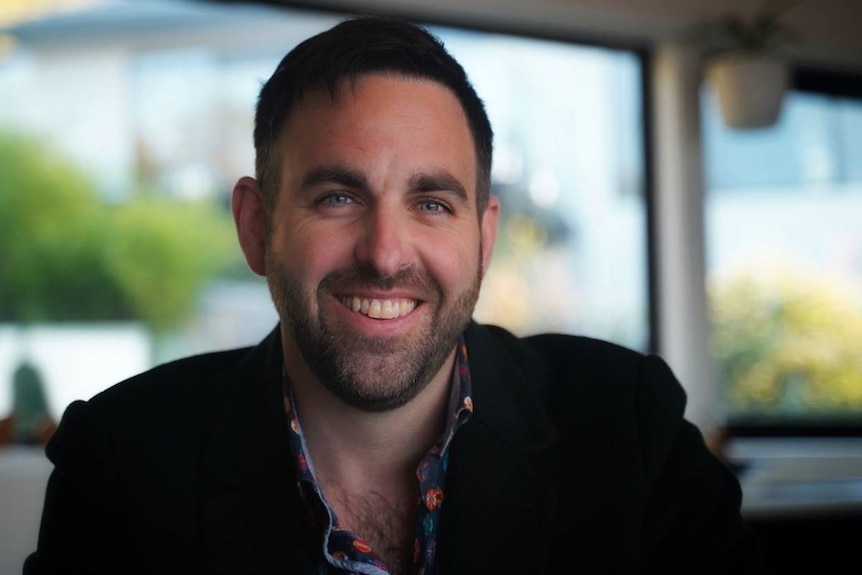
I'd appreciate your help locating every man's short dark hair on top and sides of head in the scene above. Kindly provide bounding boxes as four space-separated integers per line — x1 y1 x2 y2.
254 16 493 215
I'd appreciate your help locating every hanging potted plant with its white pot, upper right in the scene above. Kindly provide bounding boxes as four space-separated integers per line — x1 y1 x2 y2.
701 2 804 128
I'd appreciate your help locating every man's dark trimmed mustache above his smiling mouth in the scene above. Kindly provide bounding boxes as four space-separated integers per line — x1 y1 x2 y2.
318 264 443 297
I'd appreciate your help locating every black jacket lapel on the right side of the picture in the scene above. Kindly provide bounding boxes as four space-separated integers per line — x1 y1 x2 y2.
437 324 559 573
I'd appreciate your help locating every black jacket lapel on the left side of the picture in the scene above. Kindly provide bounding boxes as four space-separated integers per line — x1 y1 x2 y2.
200 328 312 574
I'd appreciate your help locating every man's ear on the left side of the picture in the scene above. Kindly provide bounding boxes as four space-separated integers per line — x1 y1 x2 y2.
231 176 267 276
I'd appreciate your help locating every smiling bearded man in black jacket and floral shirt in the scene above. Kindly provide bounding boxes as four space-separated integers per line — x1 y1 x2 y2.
25 14 762 575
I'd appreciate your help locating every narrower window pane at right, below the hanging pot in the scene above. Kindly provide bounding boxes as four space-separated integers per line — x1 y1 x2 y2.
703 88 862 425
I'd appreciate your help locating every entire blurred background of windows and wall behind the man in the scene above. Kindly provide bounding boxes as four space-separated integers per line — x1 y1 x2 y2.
0 0 862 573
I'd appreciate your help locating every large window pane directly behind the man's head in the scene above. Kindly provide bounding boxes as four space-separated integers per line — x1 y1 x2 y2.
0 0 648 424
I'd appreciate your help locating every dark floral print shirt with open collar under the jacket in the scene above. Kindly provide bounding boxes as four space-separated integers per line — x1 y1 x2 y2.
282 337 473 575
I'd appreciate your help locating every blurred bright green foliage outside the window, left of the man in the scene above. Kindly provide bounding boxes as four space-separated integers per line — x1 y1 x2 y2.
0 132 238 329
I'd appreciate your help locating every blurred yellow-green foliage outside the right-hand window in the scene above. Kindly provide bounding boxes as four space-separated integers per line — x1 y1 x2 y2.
710 261 862 417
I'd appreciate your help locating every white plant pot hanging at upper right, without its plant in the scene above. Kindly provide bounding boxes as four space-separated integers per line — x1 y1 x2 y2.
706 54 789 128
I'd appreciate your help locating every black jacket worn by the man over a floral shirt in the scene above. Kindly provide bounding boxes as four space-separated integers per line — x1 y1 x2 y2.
24 323 765 575
